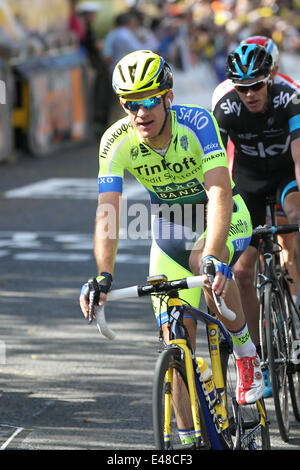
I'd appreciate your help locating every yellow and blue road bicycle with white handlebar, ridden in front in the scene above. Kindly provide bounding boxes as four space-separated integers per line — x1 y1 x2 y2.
90 275 270 450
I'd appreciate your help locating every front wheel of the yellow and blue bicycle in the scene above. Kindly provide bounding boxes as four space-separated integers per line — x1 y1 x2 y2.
152 348 209 450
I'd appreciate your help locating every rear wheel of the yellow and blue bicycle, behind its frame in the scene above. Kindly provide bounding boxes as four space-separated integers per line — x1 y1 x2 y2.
220 340 271 450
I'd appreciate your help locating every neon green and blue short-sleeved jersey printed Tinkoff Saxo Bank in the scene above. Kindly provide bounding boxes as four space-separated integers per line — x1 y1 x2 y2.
98 105 234 204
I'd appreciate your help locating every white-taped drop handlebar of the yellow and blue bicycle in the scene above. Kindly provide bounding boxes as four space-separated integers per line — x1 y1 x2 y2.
95 276 236 340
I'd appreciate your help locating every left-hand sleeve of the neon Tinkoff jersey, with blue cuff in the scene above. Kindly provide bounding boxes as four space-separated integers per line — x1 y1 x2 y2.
98 120 130 194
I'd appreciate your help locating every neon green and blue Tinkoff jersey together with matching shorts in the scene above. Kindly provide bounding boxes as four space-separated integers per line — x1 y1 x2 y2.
98 105 252 324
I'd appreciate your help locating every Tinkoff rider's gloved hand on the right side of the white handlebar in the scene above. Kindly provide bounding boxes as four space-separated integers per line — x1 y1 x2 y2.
200 256 232 298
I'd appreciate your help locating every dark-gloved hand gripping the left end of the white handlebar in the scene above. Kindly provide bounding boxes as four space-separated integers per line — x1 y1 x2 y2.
79 273 113 321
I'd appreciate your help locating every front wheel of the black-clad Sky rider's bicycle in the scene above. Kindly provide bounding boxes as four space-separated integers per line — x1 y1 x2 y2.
263 283 289 442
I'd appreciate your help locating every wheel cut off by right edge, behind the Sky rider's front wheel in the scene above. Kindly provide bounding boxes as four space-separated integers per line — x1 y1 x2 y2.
283 280 300 421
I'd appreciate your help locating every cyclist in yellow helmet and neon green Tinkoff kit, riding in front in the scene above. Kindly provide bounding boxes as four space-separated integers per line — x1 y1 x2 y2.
80 51 264 403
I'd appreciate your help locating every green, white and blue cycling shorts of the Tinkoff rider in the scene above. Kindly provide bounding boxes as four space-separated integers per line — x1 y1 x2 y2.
149 195 252 326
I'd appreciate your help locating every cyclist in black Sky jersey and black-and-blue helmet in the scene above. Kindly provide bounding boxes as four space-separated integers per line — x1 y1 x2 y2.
214 44 300 345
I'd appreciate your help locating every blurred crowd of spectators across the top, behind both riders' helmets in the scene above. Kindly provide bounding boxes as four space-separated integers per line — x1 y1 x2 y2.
0 0 300 154
